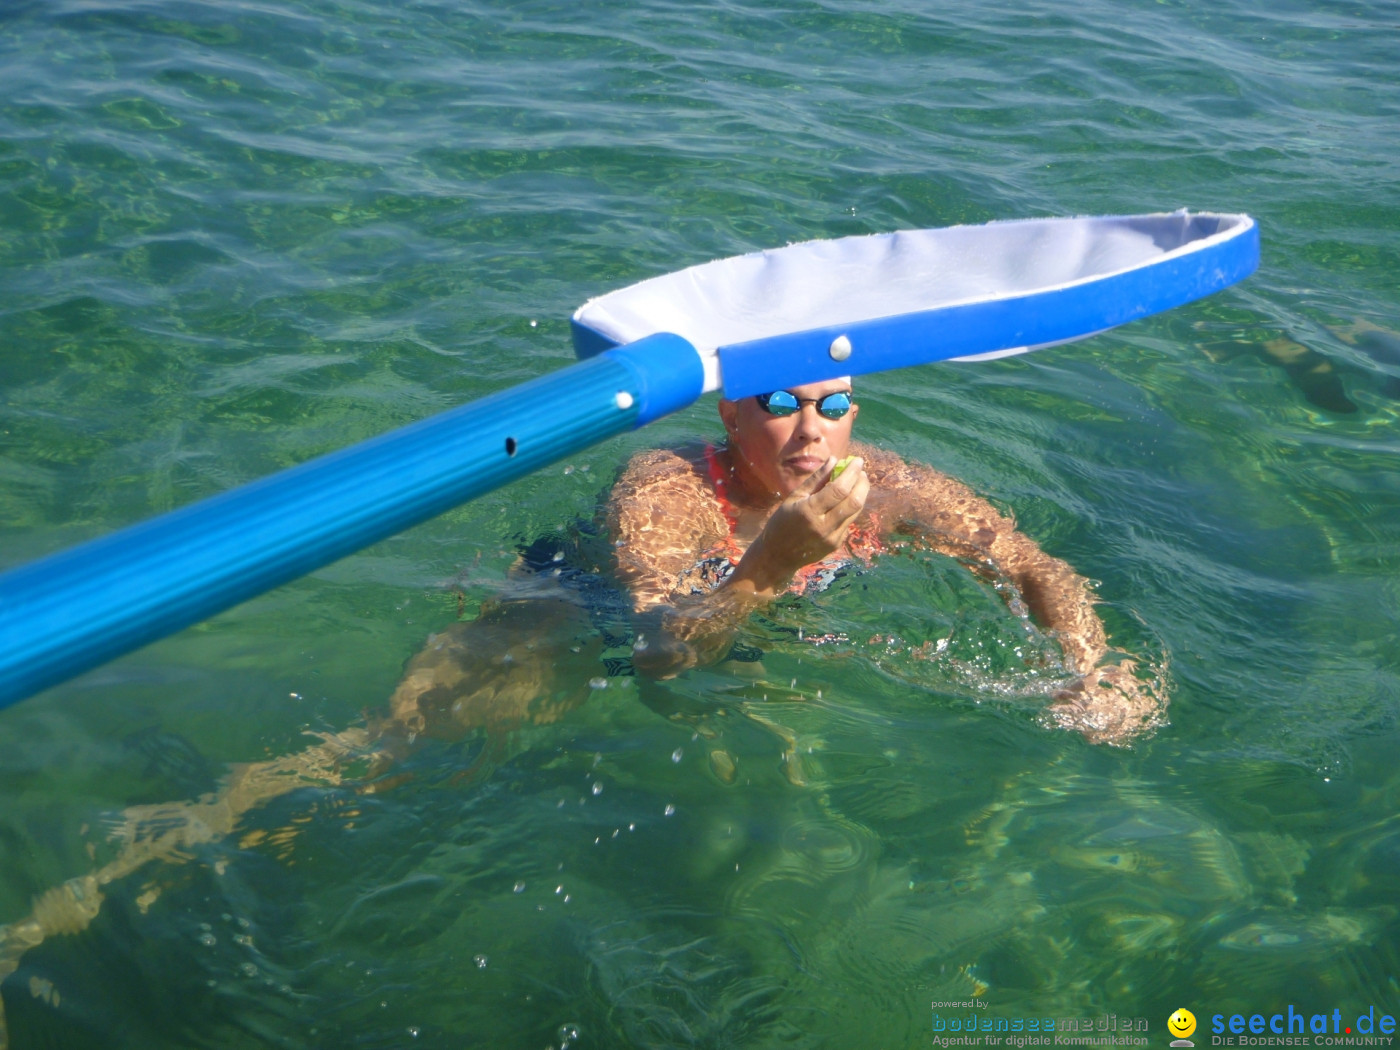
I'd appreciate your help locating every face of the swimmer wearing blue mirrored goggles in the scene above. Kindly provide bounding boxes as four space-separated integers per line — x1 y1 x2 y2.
720 378 860 497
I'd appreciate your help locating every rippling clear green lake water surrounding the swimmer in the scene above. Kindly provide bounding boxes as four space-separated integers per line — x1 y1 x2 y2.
0 0 1400 1050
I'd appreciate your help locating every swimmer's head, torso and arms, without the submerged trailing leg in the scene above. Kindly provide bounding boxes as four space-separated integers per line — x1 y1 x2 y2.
608 378 1162 743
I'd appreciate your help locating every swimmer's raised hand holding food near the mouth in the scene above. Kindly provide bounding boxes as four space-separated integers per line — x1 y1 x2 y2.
734 456 871 596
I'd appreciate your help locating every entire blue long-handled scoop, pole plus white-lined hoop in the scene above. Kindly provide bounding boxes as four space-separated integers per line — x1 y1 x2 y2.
0 211 1259 707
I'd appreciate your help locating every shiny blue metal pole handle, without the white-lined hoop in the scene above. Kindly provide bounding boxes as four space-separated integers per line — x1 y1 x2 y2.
0 335 704 707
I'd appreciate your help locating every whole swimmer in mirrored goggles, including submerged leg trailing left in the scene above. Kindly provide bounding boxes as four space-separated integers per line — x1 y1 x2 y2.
0 379 1165 1050
